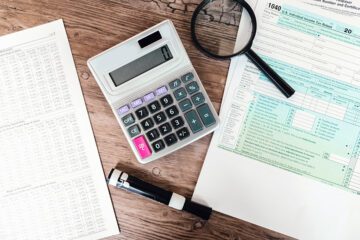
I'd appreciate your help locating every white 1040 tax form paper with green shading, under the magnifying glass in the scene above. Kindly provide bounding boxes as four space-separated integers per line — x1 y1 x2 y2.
193 0 360 240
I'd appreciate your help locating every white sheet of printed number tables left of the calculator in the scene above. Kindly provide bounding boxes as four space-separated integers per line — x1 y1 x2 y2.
0 20 119 240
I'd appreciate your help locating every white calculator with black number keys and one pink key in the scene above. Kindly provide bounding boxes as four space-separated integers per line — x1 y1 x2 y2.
88 20 219 163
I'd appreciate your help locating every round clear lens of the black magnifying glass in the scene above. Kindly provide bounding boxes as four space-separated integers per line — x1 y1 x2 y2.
194 0 253 57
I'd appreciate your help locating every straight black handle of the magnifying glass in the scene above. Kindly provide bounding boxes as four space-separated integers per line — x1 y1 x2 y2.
245 49 295 98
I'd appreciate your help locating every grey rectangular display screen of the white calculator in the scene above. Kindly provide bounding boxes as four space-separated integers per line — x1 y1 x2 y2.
110 45 173 87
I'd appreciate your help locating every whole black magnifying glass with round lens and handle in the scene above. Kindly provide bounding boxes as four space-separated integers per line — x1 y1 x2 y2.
191 0 295 98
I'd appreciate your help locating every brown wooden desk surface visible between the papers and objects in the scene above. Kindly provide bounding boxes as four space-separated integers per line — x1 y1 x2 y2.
0 0 289 240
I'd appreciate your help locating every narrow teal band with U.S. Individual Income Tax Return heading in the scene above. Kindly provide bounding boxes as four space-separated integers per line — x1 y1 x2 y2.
278 5 360 46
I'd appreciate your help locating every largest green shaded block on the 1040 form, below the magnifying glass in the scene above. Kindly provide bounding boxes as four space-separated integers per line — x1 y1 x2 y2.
220 94 360 194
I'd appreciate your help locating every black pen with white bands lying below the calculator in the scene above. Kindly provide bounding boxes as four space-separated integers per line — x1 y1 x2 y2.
107 168 212 220
